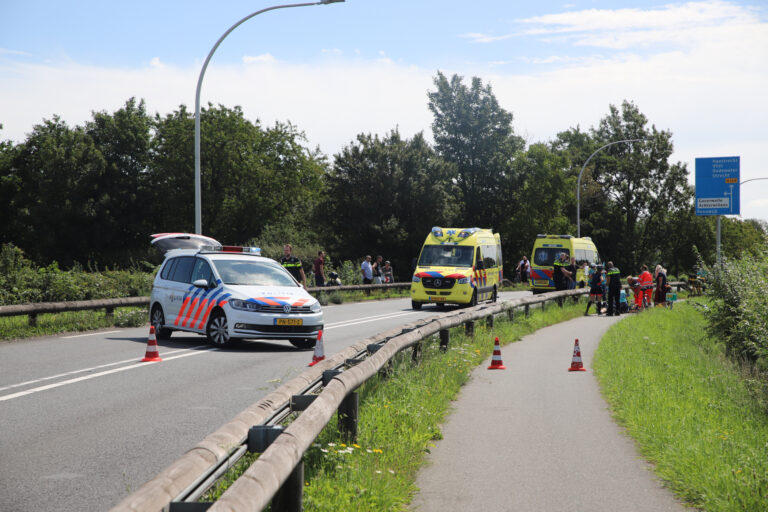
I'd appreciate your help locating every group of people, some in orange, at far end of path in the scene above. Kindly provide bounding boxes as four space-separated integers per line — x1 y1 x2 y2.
584 261 669 316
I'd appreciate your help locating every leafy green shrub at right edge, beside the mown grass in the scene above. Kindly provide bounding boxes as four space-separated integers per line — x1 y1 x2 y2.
707 243 768 370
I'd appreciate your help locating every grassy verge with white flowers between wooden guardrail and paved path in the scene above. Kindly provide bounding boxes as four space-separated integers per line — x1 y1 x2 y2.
203 301 584 511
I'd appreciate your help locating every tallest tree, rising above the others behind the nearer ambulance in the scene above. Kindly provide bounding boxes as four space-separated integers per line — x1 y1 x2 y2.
428 72 524 227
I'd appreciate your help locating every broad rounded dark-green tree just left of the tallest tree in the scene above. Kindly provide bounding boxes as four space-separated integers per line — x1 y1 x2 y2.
320 130 457 279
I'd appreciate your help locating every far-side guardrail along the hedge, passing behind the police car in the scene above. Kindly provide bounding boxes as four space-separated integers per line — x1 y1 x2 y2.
0 283 411 327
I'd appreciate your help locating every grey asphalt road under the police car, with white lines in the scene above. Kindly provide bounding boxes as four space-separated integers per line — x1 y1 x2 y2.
0 292 529 512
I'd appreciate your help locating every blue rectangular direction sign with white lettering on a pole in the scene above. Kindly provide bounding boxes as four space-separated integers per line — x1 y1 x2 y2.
696 156 741 215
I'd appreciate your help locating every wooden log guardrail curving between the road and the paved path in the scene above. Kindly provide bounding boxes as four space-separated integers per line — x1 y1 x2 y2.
112 288 588 512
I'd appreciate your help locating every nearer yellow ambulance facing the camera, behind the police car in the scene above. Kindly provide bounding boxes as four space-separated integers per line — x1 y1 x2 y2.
411 227 503 309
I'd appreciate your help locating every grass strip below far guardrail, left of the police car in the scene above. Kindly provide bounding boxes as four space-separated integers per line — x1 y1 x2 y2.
0 307 149 340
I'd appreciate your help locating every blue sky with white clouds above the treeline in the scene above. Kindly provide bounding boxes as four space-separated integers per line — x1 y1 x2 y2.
0 0 768 221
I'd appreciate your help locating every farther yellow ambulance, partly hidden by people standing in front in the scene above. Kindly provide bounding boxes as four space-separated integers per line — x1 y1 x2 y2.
529 235 600 293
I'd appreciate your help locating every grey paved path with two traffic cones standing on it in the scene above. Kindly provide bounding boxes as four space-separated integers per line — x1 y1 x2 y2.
412 316 688 512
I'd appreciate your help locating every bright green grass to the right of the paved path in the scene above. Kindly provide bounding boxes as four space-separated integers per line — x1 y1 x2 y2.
593 303 768 511
